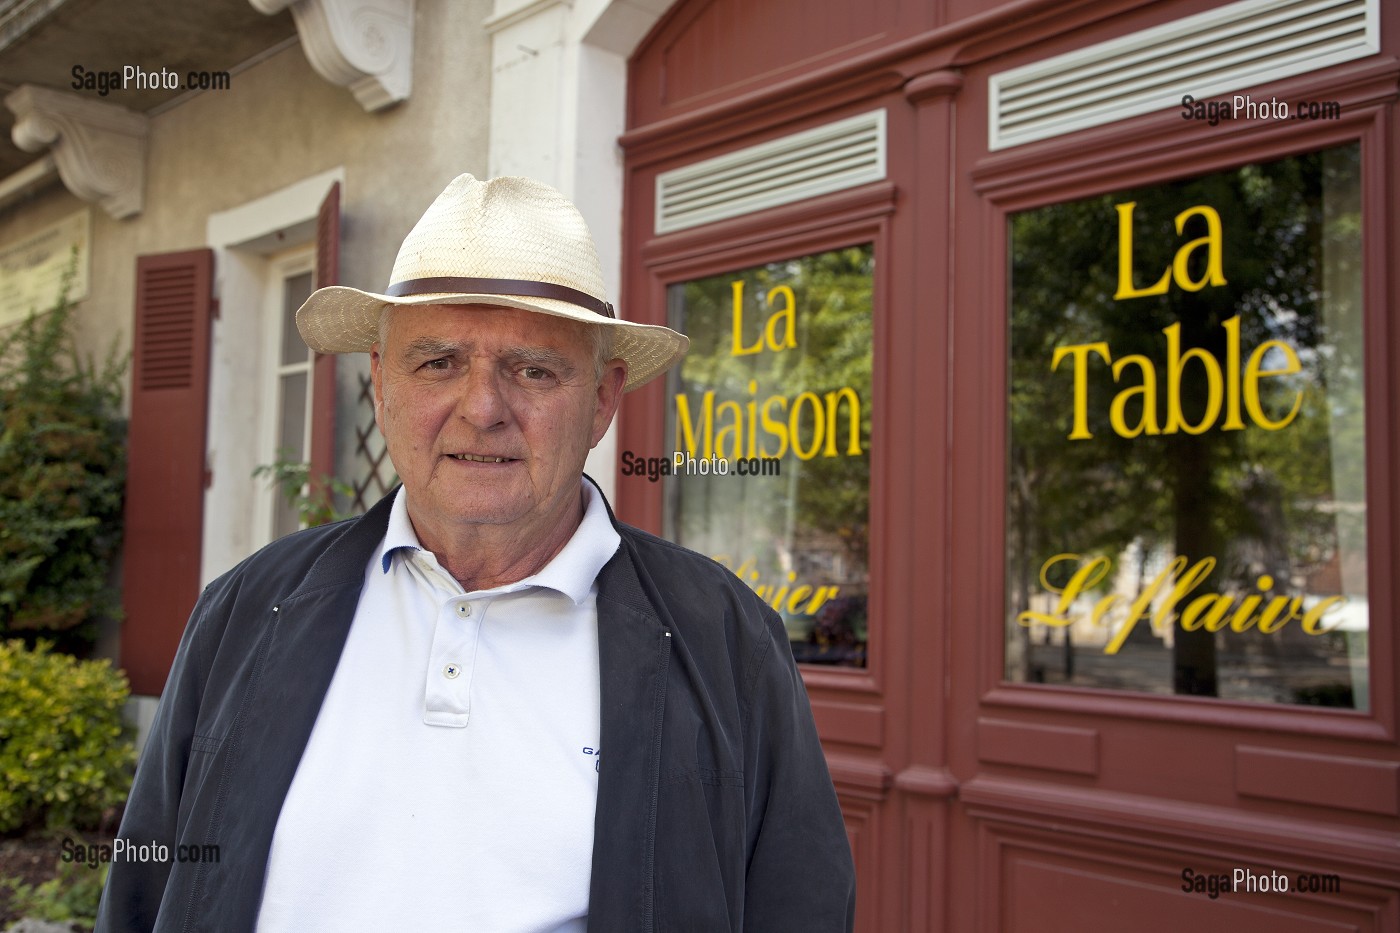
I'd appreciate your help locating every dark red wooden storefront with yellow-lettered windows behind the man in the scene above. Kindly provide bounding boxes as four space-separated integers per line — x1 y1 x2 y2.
617 0 1400 932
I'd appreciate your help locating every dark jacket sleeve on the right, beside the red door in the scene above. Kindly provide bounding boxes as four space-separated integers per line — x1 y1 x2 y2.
743 608 855 933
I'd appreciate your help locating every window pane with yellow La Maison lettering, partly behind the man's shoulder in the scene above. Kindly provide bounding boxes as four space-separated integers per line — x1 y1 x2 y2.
660 244 874 667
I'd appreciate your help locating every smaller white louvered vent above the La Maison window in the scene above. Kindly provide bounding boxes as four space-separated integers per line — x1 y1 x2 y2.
657 111 885 234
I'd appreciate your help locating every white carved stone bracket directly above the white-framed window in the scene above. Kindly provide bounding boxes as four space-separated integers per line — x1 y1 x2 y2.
248 0 414 112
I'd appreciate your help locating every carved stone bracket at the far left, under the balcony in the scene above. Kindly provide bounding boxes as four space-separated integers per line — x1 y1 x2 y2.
4 84 150 220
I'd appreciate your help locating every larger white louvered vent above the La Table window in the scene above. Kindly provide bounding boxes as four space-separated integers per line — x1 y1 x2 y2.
988 0 1380 150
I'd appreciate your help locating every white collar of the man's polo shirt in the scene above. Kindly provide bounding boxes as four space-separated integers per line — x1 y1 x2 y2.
377 479 622 605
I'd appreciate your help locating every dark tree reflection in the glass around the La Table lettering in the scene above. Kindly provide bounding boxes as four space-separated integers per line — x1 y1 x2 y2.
1007 146 1364 706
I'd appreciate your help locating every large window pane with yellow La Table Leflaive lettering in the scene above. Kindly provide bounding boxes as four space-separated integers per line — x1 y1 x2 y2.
1005 144 1369 709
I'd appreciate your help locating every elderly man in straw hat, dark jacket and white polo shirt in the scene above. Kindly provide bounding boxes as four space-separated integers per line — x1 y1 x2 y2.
98 175 854 933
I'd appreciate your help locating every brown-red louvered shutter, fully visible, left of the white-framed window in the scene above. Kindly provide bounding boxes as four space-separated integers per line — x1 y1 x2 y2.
122 249 216 695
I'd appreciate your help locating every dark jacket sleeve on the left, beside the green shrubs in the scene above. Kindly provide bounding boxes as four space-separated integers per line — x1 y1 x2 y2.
95 590 213 933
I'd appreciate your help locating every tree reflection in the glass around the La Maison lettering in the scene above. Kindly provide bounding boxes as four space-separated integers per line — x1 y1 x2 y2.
665 244 874 667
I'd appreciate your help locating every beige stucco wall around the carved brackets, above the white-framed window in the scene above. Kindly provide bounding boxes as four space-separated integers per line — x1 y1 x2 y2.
0 0 490 400
